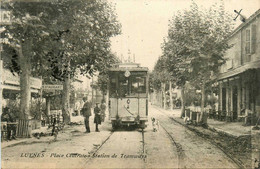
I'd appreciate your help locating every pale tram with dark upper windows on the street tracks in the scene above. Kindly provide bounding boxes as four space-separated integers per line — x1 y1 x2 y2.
108 63 148 129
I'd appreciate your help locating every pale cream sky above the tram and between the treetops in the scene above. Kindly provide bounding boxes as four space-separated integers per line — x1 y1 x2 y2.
109 0 260 70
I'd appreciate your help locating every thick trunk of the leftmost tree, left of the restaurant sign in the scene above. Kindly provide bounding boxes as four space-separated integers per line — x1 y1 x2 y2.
18 49 31 120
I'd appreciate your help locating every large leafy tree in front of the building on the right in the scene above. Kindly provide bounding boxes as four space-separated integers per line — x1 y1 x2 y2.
163 2 233 121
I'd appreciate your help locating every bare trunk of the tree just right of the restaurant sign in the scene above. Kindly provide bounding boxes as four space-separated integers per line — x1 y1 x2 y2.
62 75 70 124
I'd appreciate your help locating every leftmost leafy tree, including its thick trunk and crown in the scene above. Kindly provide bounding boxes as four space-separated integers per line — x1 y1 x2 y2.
1 2 58 119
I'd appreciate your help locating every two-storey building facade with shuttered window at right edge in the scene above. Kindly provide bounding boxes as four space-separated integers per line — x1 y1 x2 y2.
218 10 260 120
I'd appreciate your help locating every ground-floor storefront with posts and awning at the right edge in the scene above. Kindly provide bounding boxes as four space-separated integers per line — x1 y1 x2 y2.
218 61 260 120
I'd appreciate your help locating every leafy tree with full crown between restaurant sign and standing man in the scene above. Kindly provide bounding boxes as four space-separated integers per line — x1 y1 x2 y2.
44 0 120 121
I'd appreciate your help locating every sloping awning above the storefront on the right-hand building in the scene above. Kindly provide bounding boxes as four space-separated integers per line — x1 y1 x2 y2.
217 60 260 80
